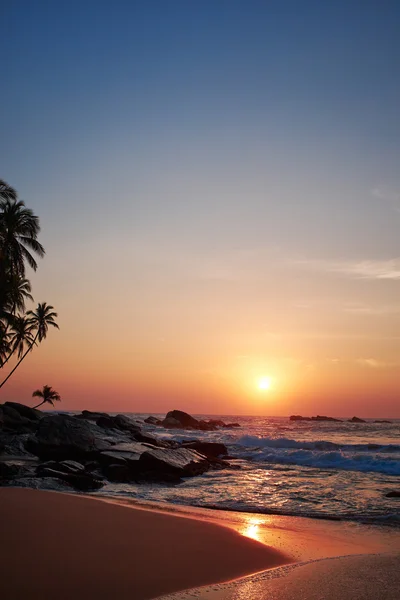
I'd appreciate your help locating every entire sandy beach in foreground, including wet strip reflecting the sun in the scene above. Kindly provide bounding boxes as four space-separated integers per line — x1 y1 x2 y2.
0 488 400 600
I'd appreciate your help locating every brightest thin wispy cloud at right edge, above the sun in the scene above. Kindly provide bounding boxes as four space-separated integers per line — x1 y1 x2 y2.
293 258 400 280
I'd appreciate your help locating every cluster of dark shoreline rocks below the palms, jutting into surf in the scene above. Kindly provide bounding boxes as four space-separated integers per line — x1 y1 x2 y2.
0 402 233 492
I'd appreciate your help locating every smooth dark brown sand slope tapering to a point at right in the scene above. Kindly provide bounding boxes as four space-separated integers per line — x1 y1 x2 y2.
0 488 290 600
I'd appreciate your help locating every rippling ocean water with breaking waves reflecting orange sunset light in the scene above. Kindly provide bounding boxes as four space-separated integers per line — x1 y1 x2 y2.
96 413 400 526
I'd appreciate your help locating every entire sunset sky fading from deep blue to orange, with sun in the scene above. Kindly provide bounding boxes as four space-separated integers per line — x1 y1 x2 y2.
0 0 400 418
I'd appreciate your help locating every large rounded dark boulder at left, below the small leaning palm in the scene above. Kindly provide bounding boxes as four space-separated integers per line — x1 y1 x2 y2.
27 415 112 460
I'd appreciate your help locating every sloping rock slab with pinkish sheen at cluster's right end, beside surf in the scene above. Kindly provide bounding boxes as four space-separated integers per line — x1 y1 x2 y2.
139 448 210 477
